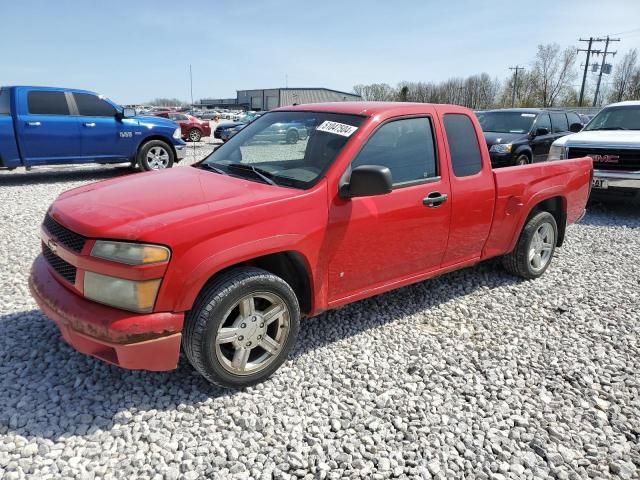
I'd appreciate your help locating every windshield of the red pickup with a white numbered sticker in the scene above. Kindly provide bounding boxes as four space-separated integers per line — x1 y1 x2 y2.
201 112 365 189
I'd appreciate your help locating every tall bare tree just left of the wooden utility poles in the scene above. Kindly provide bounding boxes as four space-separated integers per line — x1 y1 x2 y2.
532 43 577 107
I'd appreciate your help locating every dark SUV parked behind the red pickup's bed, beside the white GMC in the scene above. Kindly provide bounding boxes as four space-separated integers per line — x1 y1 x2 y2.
476 108 584 167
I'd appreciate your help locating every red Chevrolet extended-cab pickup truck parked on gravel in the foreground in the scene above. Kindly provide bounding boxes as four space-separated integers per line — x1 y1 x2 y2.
30 102 593 387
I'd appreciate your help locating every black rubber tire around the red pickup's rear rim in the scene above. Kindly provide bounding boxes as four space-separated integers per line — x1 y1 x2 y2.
502 212 558 279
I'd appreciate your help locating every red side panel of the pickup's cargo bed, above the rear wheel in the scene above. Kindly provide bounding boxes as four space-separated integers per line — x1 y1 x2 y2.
483 157 593 257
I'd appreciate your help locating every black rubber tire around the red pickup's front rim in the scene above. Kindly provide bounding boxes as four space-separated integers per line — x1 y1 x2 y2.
182 267 300 388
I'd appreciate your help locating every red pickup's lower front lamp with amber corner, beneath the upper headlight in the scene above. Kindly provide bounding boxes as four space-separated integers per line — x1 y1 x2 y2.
84 272 160 313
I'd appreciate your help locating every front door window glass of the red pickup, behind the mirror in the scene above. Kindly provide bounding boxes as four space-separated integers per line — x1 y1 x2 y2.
351 117 438 186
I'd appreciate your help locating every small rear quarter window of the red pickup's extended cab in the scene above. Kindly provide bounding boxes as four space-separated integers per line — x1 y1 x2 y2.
444 113 482 177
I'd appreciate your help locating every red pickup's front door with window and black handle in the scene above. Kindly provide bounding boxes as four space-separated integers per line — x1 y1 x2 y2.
329 116 451 304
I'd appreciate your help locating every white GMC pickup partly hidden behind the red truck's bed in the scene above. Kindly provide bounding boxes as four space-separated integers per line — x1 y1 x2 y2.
548 101 640 196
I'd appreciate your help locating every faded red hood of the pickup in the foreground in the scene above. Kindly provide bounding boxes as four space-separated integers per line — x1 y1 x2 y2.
49 167 301 240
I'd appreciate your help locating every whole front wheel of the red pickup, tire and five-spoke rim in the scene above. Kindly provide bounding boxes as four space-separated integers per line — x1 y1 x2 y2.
182 268 300 388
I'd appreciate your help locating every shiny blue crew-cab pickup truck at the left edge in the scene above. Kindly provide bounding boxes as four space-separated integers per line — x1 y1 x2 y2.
0 87 186 170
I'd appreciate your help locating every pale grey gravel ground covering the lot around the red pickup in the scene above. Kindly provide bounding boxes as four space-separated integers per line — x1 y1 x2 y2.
0 158 640 480
